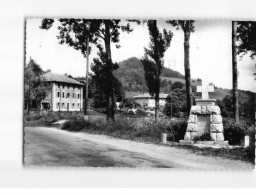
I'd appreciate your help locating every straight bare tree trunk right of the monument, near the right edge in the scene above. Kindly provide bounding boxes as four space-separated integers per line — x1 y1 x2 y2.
232 21 239 123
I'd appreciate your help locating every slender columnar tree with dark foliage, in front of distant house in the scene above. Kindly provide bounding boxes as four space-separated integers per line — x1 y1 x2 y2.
141 20 173 120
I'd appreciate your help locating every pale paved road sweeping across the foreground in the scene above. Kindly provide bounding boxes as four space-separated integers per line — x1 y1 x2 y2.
24 127 253 169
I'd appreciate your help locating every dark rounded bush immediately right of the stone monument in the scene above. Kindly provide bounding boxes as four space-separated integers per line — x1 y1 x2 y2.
223 118 247 145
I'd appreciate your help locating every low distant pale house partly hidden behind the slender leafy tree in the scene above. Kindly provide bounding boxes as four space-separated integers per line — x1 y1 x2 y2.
133 93 168 108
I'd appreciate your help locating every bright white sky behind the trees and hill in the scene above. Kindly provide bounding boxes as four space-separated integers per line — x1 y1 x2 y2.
26 18 256 92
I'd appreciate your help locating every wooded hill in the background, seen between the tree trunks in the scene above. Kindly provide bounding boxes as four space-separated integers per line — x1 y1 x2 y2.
114 57 254 102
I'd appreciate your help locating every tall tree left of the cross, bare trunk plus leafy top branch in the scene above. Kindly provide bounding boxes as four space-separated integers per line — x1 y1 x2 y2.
166 20 195 115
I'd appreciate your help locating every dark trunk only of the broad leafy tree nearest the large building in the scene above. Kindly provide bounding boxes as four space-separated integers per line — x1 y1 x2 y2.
105 20 115 121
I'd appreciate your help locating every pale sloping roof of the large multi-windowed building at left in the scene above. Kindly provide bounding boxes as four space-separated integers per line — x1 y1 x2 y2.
43 72 84 85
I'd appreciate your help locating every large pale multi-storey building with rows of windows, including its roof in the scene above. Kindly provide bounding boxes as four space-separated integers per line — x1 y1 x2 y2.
41 72 84 111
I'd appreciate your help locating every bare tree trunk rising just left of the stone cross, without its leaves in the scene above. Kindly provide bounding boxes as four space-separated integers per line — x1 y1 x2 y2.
183 21 192 116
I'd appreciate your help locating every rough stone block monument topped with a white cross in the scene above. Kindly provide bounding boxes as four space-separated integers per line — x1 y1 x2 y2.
180 81 228 145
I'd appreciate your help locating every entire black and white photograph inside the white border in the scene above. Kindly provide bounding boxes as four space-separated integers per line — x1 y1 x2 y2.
23 17 256 170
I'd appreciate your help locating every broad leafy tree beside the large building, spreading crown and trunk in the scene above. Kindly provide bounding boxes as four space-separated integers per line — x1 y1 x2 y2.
41 18 132 121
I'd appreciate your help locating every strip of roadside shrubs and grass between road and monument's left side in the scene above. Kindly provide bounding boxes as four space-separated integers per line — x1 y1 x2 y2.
61 117 187 143
